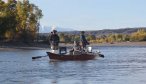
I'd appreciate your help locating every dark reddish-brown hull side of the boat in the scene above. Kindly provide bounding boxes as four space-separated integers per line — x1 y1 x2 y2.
47 52 97 60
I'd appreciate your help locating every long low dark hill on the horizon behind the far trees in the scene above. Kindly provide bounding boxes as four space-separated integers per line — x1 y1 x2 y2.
38 27 146 36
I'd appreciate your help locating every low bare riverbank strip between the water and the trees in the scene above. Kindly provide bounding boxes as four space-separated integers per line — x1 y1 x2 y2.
0 41 146 50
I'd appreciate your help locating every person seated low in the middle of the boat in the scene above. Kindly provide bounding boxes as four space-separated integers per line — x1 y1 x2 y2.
70 41 82 55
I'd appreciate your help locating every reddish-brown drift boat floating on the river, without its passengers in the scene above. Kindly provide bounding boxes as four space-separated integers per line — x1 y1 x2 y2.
46 47 104 60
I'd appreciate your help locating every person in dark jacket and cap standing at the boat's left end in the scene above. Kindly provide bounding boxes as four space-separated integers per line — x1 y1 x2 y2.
50 30 60 50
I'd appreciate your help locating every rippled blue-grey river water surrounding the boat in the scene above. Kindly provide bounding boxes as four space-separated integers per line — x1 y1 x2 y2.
0 46 146 84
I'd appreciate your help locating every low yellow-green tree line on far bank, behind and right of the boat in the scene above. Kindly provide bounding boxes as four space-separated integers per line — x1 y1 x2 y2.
56 29 146 43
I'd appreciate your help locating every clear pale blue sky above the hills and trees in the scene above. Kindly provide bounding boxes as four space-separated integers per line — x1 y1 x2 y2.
29 0 146 30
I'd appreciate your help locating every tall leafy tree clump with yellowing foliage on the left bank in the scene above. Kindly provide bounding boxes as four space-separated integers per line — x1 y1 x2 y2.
0 0 43 42
